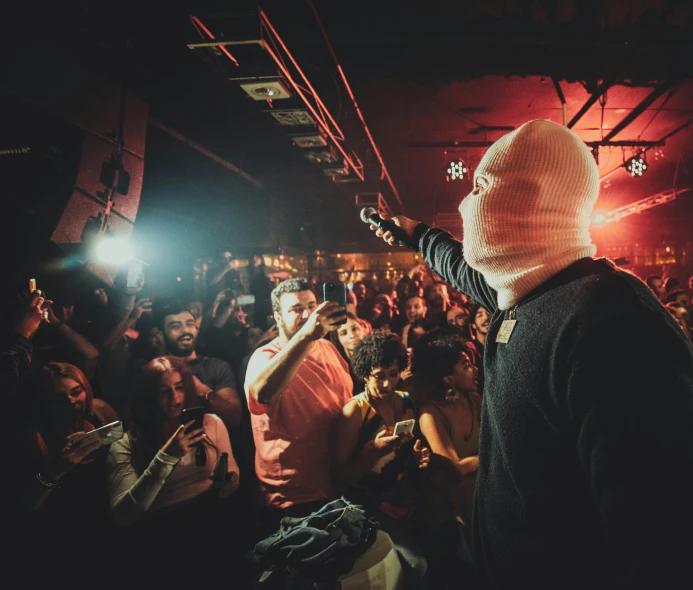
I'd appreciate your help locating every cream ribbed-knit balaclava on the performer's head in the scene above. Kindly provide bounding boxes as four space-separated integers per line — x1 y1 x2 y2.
460 121 599 309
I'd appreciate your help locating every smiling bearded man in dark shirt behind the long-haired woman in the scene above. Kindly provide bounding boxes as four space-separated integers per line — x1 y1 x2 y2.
153 299 242 430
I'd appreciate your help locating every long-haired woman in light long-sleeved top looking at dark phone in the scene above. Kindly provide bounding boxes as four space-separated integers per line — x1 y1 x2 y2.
108 357 239 532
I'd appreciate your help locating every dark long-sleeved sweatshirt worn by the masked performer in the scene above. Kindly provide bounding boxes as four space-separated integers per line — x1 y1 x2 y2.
414 224 693 590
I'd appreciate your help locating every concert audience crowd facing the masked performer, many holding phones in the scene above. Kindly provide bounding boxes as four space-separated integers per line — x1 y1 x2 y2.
2 246 693 588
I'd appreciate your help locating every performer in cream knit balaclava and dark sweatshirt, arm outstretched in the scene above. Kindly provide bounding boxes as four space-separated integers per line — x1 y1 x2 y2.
377 121 693 590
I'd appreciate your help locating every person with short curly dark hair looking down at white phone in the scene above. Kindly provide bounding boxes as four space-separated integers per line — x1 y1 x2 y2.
336 332 430 588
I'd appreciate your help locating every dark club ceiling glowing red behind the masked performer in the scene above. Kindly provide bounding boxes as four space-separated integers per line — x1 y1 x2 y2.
4 0 693 260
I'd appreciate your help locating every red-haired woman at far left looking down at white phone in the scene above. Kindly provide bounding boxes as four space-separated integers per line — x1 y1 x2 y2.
9 363 118 575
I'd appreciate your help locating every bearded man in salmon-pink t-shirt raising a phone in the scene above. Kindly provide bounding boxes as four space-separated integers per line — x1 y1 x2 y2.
245 279 353 516
